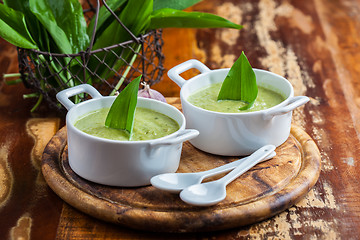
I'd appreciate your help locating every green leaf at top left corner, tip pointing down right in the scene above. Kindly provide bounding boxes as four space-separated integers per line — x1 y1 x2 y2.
0 4 37 49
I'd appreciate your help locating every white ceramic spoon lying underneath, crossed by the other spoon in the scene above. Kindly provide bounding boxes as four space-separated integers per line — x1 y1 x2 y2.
150 145 276 193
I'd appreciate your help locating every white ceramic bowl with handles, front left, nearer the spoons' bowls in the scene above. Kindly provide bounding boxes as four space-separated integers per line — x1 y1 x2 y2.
56 84 199 187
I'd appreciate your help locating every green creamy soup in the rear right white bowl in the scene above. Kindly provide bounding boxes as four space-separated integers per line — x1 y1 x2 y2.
187 82 285 113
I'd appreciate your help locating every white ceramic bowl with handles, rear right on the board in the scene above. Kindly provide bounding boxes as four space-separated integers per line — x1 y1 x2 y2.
168 59 309 156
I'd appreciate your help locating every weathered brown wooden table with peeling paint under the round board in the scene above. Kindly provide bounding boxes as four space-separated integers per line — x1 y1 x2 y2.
0 0 360 239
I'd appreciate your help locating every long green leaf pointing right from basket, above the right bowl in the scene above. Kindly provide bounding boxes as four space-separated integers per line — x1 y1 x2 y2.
149 8 242 29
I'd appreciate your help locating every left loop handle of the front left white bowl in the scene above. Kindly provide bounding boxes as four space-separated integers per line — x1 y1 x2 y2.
56 84 103 110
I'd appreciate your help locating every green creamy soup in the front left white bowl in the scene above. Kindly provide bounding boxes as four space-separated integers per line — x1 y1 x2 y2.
75 108 180 141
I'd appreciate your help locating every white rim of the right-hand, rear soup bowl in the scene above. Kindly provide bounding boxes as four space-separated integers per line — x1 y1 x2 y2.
180 68 294 116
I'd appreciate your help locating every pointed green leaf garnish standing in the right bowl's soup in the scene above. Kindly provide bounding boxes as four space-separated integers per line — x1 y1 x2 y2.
218 52 258 110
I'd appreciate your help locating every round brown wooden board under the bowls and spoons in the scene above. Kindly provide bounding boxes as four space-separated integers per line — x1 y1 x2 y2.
42 126 321 232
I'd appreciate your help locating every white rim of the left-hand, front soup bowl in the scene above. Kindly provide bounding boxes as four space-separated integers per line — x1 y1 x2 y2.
66 96 186 145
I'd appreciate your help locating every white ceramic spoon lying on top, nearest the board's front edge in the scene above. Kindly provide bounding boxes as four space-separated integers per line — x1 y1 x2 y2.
180 145 275 206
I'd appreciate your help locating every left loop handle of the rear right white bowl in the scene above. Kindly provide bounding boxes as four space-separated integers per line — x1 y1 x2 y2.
167 59 211 88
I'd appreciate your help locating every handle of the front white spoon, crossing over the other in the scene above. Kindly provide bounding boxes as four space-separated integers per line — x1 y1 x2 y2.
217 145 275 186
